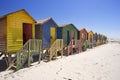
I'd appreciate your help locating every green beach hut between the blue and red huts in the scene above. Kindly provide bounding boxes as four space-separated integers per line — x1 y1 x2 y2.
57 24 78 47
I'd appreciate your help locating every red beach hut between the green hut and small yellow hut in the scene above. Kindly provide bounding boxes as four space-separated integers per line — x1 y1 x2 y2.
79 28 88 51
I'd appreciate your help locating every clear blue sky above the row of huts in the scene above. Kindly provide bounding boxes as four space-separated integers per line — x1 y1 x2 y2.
0 0 120 39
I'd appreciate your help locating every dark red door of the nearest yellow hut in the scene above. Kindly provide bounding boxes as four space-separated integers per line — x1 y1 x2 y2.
23 23 32 44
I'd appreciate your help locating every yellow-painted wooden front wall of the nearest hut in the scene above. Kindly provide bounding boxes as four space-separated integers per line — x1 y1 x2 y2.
0 9 35 53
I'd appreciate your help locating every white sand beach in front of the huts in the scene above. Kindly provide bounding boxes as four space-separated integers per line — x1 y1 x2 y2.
0 43 120 80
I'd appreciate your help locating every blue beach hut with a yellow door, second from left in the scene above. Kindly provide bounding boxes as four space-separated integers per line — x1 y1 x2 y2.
35 18 58 49
